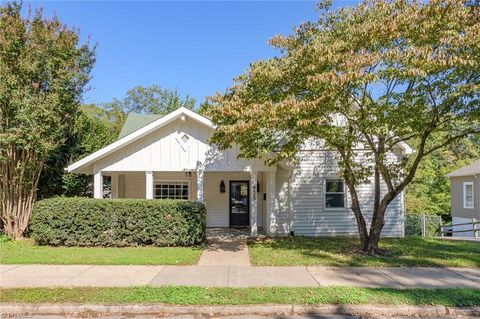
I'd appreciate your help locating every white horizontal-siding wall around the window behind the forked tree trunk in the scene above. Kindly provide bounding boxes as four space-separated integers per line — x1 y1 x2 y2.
291 150 404 237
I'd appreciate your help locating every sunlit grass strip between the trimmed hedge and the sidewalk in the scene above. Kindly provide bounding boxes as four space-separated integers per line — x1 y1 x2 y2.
0 241 203 265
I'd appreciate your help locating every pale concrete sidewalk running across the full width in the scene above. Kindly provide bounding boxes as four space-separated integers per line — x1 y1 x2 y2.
0 265 480 289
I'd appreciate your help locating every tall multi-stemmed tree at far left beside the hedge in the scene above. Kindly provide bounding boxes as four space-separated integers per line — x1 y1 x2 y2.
0 2 95 239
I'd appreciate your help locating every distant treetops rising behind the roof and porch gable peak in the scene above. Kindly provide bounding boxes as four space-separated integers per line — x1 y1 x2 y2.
104 84 195 133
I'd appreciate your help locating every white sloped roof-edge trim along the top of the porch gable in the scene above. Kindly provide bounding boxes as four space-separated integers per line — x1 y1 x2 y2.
66 107 215 173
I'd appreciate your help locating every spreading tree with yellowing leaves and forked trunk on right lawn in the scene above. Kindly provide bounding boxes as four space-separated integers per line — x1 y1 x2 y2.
208 0 480 254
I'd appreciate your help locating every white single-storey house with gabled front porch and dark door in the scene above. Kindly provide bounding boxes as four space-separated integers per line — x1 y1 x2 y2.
67 108 412 237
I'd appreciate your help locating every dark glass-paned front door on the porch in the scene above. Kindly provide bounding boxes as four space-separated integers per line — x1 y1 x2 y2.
230 181 250 227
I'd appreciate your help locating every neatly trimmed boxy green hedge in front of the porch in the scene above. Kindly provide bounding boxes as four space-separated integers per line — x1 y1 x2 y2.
30 197 206 247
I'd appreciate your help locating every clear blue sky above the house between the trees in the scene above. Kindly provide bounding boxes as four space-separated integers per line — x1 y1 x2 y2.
24 1 358 104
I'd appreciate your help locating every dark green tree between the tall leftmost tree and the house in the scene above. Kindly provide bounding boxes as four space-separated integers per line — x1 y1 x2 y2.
37 104 117 198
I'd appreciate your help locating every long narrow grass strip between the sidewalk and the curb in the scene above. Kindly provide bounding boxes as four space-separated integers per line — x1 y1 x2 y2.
0 286 480 306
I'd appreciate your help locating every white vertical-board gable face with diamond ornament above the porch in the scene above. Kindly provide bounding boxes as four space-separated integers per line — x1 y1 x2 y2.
94 118 272 172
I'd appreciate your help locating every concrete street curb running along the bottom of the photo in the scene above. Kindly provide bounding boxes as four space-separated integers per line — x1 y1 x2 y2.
0 303 480 317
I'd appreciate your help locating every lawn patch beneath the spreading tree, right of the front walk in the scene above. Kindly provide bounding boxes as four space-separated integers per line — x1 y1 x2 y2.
249 237 480 267
